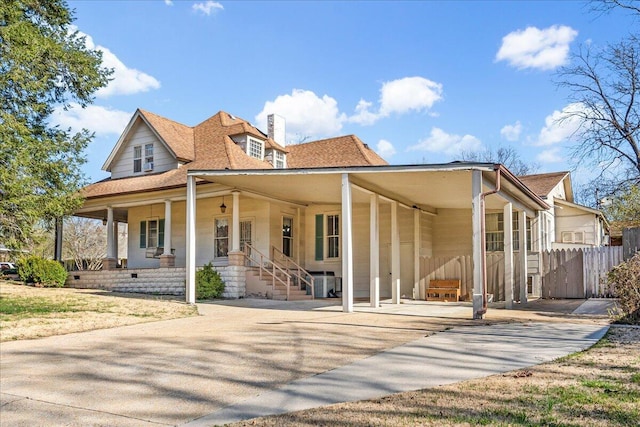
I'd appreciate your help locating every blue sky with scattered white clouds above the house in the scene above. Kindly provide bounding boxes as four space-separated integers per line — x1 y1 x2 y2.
53 0 635 189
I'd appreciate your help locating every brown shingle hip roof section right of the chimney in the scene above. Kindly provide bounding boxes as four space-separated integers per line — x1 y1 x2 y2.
287 135 388 168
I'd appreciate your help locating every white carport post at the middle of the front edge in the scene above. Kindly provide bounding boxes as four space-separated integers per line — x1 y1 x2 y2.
342 173 353 313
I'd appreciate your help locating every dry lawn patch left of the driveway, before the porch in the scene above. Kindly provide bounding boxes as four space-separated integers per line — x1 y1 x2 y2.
0 282 198 341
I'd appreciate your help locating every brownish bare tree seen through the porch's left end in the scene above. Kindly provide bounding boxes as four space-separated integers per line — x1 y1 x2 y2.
62 217 107 270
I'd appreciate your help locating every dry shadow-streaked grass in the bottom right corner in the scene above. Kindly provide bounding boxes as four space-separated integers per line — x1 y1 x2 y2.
232 327 640 427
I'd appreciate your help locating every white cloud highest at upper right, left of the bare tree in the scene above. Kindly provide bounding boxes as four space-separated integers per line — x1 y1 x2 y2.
496 25 578 70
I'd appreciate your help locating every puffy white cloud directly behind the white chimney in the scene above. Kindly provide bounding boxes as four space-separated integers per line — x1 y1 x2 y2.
255 89 346 139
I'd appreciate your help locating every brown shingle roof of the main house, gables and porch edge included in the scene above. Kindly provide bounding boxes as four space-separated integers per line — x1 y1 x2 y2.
83 109 387 198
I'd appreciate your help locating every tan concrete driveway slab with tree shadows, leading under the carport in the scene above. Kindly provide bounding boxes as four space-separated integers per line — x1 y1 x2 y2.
0 300 606 426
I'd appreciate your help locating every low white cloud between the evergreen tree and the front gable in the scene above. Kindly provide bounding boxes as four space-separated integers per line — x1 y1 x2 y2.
51 103 131 136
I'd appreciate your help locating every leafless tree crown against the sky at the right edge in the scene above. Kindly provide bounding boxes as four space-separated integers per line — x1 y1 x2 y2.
558 36 640 194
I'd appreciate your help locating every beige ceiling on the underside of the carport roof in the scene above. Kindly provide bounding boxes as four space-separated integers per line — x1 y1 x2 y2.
190 168 520 210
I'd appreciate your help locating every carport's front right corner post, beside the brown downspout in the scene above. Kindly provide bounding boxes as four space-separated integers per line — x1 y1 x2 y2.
471 170 485 319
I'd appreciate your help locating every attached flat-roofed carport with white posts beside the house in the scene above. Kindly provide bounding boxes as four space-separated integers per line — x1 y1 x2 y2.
186 162 548 319
